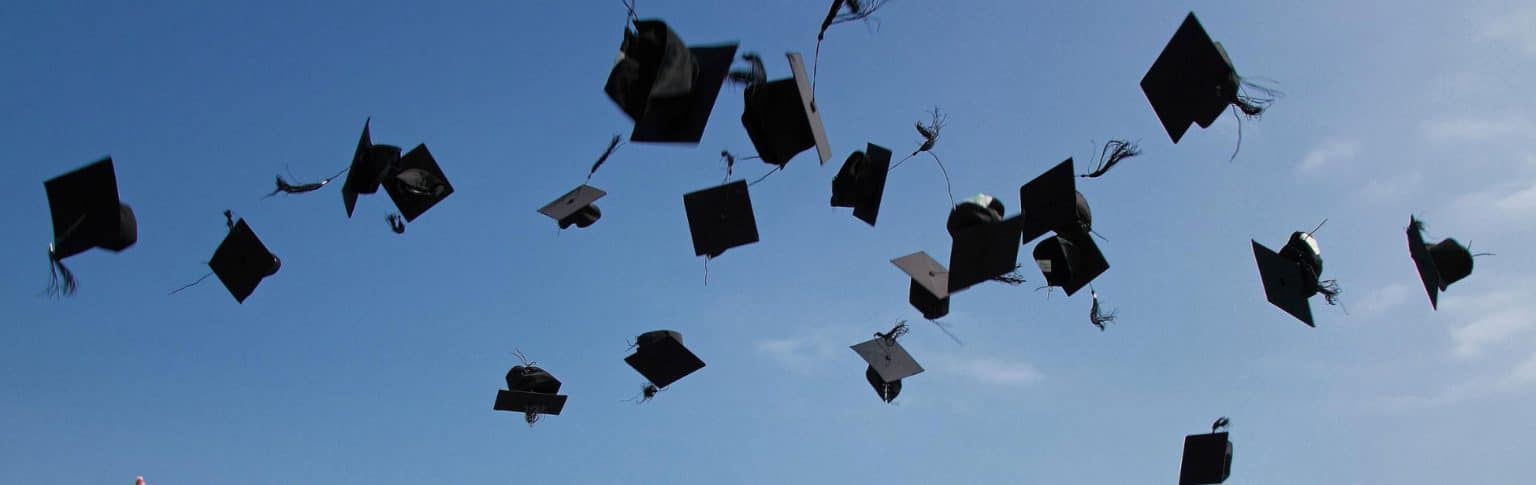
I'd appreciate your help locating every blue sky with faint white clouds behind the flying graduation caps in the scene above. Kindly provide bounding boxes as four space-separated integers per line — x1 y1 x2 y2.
0 0 1536 485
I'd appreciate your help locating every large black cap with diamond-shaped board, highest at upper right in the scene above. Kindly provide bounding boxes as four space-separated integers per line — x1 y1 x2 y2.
1141 12 1241 143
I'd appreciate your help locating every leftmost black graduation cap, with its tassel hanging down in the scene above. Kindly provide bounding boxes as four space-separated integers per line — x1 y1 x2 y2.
43 157 138 295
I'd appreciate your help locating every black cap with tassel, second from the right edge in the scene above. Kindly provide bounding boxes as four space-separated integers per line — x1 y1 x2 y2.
1250 232 1339 327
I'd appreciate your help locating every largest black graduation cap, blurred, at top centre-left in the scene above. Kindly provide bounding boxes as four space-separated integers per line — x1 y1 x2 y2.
604 20 736 143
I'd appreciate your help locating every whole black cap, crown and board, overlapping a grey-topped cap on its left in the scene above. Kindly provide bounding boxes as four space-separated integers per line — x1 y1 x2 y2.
946 193 1023 293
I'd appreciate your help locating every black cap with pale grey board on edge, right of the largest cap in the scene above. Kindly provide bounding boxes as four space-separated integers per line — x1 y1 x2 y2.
742 52 833 166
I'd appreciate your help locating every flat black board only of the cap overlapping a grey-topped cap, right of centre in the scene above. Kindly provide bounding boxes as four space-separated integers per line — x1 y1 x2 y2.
948 216 1023 293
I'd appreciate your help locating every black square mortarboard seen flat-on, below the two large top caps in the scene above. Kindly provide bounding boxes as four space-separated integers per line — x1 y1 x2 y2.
682 180 757 258
